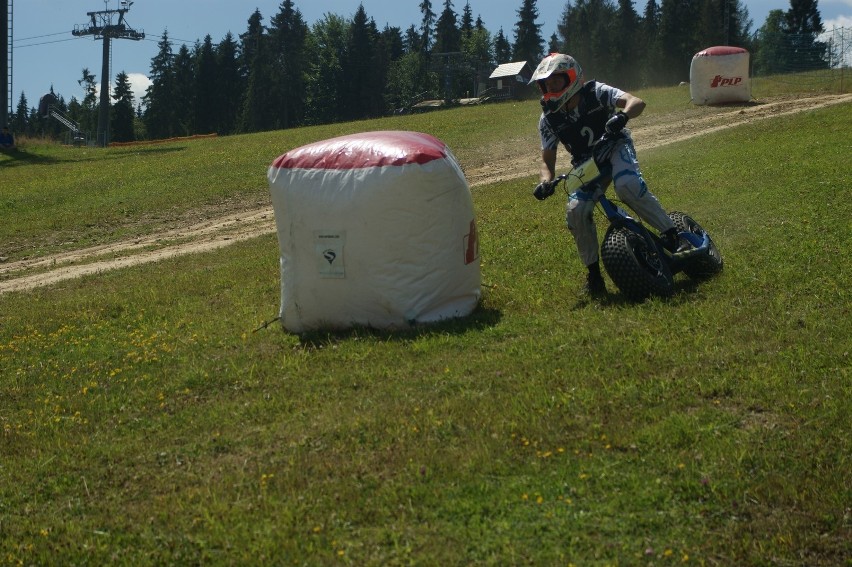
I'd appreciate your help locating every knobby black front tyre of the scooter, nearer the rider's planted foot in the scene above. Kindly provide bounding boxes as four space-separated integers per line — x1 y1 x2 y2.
601 226 674 301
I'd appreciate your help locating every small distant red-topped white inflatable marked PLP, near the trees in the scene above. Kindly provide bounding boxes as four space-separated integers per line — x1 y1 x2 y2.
689 46 751 105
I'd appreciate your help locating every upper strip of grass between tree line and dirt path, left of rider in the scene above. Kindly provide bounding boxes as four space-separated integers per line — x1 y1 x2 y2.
0 101 539 259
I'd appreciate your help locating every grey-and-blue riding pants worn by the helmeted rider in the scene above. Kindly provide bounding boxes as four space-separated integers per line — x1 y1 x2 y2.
565 137 674 266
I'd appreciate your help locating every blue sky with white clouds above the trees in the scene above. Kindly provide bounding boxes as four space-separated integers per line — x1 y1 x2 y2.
10 0 852 111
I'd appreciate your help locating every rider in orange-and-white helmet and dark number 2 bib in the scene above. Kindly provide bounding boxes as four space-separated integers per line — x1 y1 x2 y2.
530 53 689 296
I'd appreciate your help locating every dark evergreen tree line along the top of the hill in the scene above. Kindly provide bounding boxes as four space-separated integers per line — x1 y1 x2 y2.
12 0 826 141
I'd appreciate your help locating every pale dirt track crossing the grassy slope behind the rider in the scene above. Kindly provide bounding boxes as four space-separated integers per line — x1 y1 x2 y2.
0 94 852 293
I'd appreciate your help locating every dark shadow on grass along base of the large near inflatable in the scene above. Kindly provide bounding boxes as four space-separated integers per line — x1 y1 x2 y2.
284 305 503 350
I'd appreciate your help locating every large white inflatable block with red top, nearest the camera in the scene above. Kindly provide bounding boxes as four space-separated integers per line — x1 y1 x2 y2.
268 131 481 333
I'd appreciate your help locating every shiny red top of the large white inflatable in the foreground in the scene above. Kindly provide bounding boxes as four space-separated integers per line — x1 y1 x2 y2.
272 130 447 169
